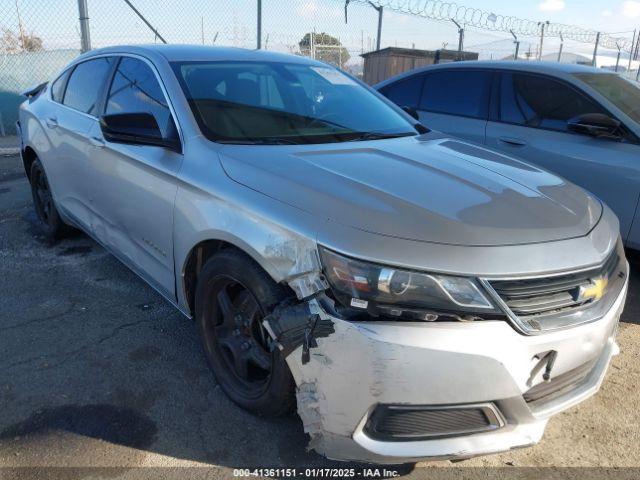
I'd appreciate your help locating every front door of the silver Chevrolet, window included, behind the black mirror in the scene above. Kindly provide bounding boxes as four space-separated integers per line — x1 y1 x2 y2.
90 57 183 299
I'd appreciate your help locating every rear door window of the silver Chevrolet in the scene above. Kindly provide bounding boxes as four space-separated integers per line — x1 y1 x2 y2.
63 57 113 115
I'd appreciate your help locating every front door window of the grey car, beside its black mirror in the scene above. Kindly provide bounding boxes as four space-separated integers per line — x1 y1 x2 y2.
500 73 606 131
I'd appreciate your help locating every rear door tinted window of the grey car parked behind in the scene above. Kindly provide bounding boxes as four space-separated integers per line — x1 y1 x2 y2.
420 70 491 118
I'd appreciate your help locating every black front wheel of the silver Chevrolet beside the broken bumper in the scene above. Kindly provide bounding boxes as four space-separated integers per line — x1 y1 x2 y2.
195 249 295 417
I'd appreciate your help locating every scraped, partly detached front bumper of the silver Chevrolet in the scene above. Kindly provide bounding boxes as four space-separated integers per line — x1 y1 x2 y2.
270 278 627 463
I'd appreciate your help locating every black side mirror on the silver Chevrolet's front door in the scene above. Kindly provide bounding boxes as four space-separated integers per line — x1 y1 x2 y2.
100 113 181 152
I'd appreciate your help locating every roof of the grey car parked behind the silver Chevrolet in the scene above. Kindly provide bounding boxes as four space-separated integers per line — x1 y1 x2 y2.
374 60 612 88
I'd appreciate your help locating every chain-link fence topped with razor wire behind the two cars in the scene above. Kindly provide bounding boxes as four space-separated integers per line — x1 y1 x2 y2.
0 0 638 137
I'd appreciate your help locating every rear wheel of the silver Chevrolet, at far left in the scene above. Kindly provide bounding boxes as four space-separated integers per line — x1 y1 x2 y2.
29 159 73 240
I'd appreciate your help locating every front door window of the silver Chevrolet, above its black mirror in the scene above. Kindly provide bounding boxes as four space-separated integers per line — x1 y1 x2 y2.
105 57 173 137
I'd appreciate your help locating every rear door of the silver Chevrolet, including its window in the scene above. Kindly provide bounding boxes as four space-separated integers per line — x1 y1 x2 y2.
44 57 113 228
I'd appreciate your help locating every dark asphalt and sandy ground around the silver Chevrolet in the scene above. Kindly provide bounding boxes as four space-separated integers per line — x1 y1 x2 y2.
0 152 640 478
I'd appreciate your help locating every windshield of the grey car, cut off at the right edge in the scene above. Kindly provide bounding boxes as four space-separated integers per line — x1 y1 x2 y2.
574 73 640 122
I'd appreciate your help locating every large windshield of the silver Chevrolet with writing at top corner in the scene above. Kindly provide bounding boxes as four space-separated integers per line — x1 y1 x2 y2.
172 62 417 144
